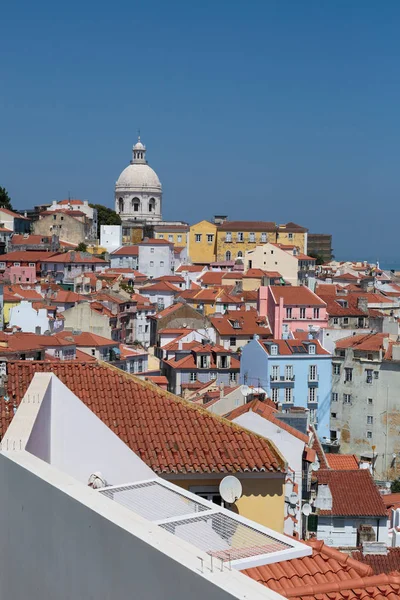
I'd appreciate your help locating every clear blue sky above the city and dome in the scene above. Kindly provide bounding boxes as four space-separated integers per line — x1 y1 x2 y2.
0 0 400 261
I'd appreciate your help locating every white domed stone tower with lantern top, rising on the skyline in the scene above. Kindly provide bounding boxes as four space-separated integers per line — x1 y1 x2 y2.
115 136 162 223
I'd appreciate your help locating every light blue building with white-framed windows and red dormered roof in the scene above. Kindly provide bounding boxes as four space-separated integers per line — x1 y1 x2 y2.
240 336 332 441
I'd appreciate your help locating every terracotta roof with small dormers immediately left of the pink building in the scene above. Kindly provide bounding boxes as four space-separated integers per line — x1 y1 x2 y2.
210 309 271 337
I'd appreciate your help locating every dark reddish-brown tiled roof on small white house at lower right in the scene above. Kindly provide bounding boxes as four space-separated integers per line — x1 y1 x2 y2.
316 469 386 517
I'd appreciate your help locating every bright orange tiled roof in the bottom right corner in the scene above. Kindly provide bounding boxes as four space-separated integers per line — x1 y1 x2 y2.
242 540 400 600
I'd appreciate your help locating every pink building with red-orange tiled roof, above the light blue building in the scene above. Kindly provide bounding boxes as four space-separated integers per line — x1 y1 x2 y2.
258 285 328 339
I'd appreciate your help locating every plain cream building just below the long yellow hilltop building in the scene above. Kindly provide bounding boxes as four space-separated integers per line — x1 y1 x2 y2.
244 243 298 285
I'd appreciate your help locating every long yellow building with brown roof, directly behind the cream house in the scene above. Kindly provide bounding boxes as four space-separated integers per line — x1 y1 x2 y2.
217 221 308 261
